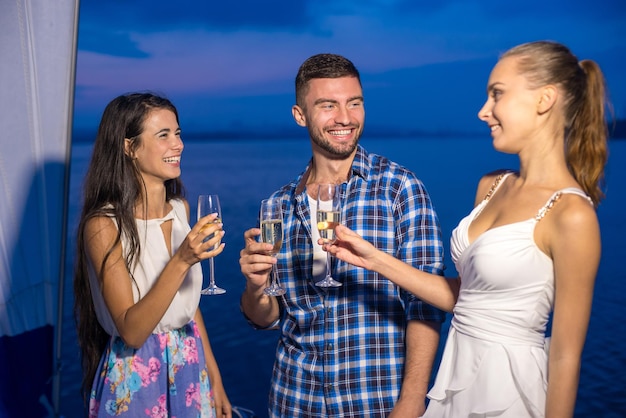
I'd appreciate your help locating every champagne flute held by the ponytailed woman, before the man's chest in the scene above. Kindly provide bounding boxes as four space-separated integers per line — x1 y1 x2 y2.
315 184 341 287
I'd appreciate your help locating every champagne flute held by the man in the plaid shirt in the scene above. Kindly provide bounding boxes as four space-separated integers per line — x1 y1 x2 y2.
261 199 285 296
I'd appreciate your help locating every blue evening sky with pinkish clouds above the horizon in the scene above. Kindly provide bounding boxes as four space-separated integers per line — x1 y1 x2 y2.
74 0 626 136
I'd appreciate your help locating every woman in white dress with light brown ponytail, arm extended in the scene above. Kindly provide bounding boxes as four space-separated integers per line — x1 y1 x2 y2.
326 41 607 418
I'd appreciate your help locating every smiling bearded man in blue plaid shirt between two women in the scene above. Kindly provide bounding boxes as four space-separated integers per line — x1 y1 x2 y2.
240 54 445 417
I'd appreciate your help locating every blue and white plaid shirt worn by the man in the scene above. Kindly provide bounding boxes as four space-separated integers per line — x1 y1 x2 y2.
254 145 445 417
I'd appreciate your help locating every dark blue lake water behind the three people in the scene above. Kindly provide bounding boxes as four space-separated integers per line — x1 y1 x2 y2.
60 136 626 418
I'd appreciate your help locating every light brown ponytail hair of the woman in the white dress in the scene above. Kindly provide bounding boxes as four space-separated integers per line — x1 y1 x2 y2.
502 41 609 206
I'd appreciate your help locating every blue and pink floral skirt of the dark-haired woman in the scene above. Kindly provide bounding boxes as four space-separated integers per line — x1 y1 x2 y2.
89 321 215 418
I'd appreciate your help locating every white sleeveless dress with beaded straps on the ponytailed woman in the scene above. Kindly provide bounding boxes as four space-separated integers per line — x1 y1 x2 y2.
423 171 589 418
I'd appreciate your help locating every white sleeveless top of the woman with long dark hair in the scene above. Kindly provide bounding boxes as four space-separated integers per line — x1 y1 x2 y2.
89 199 202 336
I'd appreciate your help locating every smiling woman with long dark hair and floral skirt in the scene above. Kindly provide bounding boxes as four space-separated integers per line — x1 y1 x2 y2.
74 93 231 417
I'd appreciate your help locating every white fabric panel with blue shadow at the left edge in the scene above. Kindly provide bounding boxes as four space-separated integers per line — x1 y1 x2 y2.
0 0 78 336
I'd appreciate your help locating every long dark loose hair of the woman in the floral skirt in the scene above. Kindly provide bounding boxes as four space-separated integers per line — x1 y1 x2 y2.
74 93 185 401
